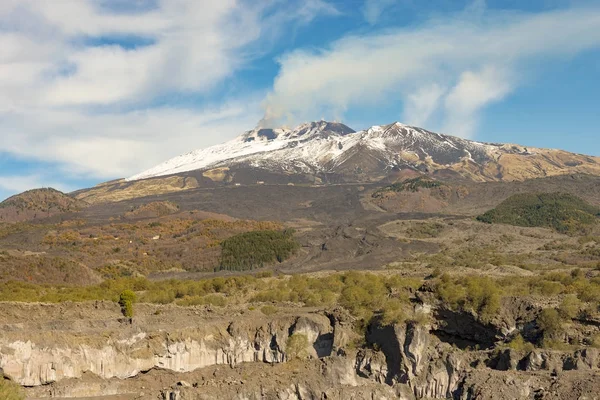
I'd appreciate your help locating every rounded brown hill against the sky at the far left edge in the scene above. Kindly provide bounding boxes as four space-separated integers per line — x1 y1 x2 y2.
0 188 88 223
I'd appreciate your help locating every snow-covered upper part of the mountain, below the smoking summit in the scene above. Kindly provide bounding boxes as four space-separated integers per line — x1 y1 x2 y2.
127 121 498 181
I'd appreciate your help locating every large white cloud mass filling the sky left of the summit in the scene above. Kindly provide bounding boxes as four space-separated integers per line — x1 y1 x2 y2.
0 0 337 190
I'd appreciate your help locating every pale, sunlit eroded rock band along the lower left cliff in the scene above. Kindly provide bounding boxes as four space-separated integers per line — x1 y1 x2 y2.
0 315 333 386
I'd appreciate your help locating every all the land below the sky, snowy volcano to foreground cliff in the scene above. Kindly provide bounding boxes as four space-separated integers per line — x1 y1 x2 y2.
0 121 600 400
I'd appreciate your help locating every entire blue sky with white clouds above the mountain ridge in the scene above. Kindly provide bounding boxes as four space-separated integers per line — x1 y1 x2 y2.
0 0 600 198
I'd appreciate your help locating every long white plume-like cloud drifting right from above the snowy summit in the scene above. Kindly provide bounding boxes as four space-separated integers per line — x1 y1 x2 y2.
264 7 600 136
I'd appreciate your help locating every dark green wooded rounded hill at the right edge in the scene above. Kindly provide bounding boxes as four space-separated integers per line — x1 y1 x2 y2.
477 193 600 233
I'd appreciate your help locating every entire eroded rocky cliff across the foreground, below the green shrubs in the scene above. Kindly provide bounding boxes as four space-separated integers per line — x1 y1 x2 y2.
0 303 600 400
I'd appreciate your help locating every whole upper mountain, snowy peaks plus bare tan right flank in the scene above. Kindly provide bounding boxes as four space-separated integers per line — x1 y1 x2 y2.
127 121 600 183
